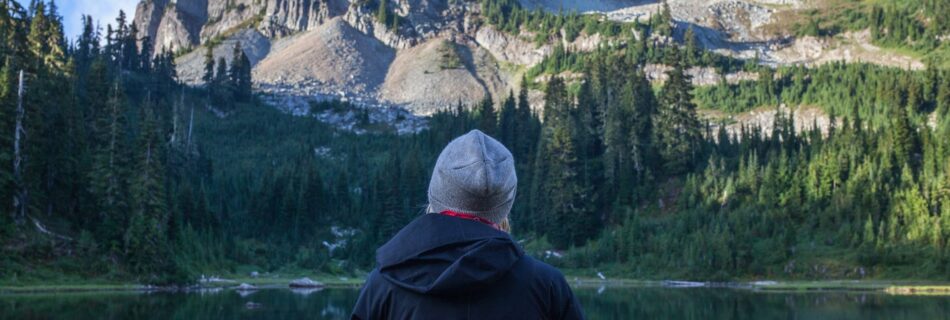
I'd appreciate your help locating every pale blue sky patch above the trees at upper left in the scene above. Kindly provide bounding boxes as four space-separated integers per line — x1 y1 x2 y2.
17 0 139 39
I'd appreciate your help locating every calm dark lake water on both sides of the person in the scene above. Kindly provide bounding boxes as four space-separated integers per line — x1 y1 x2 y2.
0 288 950 320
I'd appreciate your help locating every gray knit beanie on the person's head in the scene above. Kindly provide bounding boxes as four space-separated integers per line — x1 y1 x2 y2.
429 130 518 223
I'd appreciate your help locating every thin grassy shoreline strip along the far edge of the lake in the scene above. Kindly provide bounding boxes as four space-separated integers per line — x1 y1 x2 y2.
7 276 950 295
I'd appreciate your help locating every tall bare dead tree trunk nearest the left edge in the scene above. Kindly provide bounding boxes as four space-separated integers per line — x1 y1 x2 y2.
13 70 29 225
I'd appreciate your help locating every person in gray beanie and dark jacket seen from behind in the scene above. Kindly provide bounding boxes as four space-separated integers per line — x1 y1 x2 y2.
351 130 584 320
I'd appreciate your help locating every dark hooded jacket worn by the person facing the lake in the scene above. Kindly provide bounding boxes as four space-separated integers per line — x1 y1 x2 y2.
352 214 584 320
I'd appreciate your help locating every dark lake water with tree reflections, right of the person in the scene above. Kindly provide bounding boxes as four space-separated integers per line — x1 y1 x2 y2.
577 288 950 319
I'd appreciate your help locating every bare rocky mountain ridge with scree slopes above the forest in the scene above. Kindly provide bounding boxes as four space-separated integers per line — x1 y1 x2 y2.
135 0 920 124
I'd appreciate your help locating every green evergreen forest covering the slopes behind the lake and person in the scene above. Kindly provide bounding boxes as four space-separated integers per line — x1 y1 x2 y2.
0 0 950 284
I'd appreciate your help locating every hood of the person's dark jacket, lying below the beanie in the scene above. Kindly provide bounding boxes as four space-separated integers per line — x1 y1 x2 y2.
376 214 524 295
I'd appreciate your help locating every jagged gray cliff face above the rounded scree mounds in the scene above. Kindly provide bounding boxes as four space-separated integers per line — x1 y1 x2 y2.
135 0 477 51
